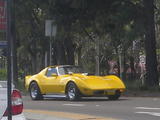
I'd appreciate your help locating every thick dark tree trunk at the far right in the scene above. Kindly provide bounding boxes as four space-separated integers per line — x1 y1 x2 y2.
143 0 159 87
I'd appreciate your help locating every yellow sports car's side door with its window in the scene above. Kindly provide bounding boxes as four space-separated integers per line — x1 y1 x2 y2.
43 67 61 93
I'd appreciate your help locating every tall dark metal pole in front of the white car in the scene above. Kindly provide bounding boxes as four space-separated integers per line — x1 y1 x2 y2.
6 0 12 120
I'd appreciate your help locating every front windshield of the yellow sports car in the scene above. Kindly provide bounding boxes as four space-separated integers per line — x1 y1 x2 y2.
58 66 85 75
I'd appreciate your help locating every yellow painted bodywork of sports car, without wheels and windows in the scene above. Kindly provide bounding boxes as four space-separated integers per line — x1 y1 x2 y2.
25 66 126 96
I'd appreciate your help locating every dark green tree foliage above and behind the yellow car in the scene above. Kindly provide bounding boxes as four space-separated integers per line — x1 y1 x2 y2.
15 0 160 87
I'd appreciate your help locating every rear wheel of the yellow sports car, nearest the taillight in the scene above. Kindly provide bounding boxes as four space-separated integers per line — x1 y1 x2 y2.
29 82 43 100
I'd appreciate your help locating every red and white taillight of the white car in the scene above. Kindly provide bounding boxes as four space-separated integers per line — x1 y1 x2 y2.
4 90 23 116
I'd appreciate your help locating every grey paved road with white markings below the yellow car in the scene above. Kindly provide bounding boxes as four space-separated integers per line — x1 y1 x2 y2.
24 96 160 120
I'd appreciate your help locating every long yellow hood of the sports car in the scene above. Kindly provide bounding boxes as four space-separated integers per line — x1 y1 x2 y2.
73 74 123 89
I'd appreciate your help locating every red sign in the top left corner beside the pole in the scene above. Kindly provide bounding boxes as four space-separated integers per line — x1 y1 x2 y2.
0 0 7 30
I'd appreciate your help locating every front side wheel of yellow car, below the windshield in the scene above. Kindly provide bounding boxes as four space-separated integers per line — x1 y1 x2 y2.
66 82 80 101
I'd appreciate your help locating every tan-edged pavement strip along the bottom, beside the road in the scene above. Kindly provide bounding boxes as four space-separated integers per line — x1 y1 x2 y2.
24 109 117 120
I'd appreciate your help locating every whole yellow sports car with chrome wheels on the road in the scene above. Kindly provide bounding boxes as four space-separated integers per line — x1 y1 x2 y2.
25 65 125 101
